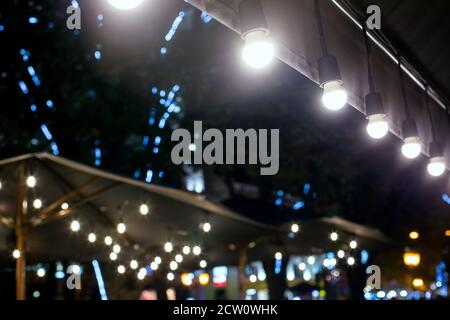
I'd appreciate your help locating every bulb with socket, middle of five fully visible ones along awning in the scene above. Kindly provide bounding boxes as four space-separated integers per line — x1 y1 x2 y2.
365 92 389 140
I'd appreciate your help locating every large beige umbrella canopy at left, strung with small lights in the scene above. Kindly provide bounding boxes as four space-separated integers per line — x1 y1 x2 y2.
0 153 281 265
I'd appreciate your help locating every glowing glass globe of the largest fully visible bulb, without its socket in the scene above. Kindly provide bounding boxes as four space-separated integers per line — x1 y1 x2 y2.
242 29 275 69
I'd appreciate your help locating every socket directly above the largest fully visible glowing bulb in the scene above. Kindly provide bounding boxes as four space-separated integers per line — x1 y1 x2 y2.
239 0 269 39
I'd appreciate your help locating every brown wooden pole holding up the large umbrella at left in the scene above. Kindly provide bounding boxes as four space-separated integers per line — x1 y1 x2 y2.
15 162 26 300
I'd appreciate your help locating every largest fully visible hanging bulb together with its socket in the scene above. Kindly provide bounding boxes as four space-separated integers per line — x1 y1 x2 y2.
239 0 275 69
